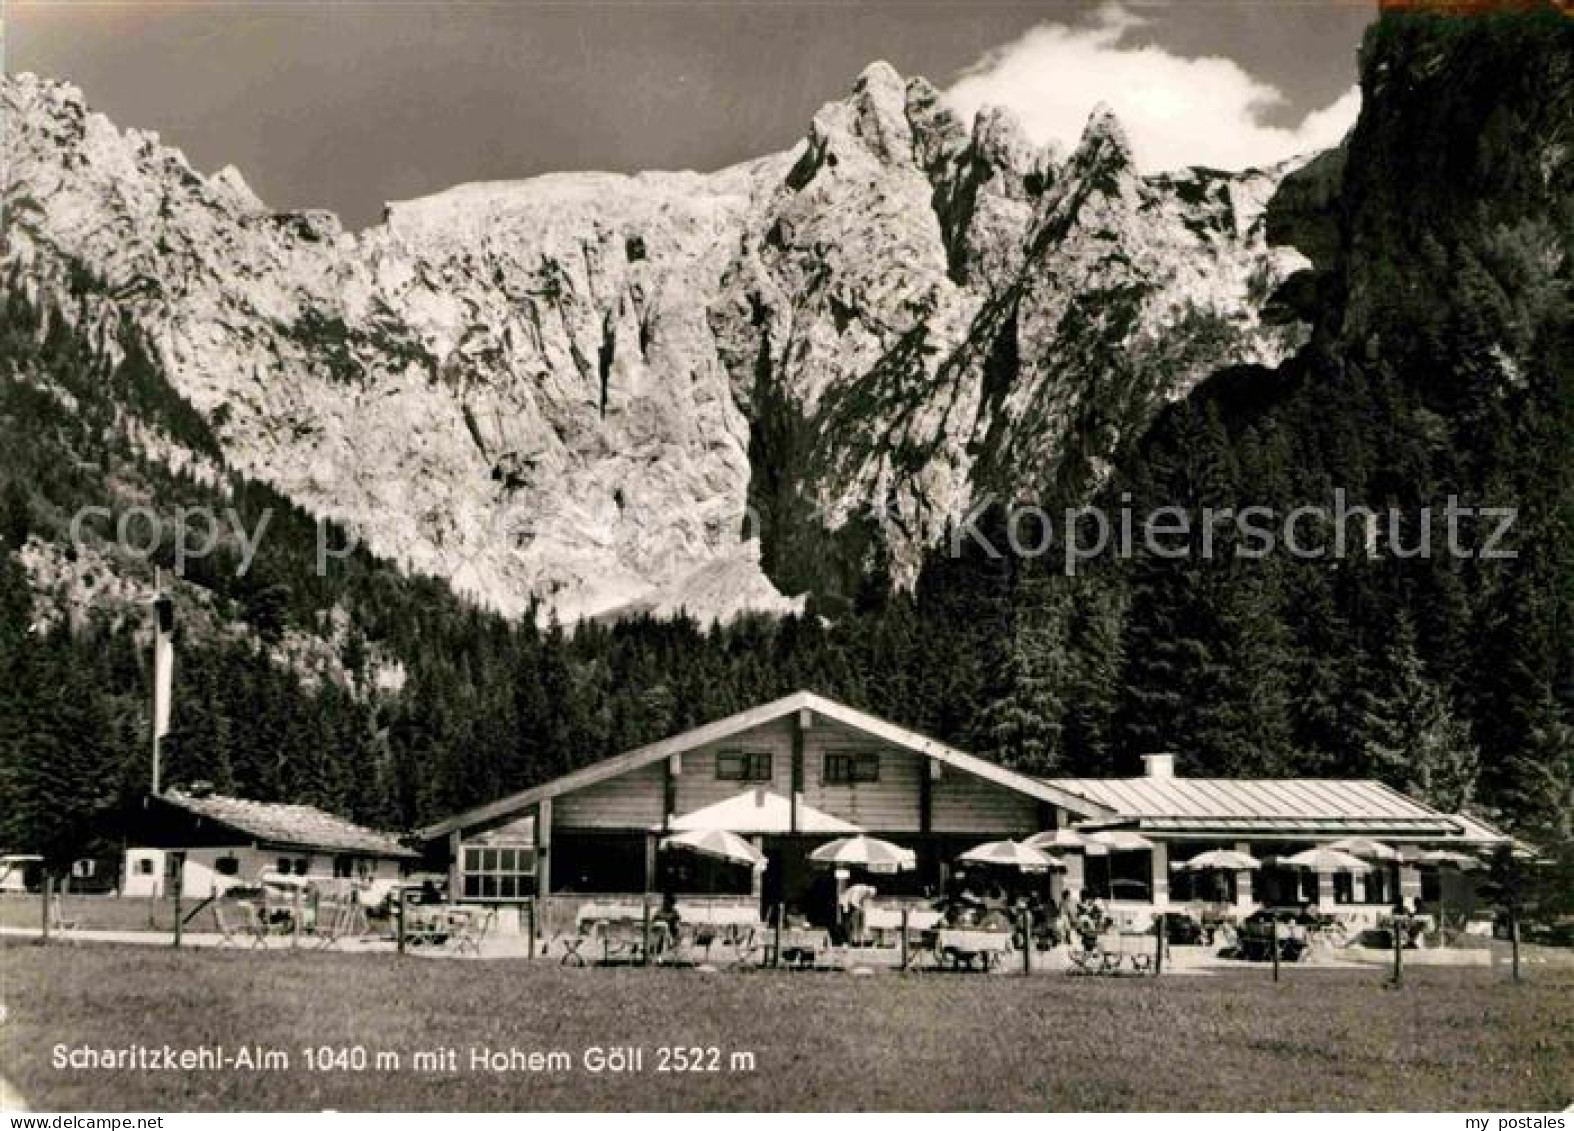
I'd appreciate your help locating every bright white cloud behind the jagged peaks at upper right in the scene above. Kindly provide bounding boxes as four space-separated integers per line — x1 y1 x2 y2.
946 5 1362 171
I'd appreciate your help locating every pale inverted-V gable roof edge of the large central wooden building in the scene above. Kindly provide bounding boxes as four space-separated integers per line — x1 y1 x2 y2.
420 691 1110 840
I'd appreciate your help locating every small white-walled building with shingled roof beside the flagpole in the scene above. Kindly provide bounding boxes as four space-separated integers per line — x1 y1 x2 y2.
121 790 419 898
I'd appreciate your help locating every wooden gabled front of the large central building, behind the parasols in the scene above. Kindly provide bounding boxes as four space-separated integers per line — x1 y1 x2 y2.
425 692 1110 898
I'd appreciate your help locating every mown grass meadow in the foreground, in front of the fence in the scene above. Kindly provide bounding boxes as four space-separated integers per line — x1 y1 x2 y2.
0 942 1574 1111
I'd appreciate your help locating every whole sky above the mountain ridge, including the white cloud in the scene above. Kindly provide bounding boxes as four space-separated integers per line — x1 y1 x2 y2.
5 0 1373 227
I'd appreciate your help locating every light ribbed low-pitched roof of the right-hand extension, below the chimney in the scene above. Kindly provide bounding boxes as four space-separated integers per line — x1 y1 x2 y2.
1050 777 1462 837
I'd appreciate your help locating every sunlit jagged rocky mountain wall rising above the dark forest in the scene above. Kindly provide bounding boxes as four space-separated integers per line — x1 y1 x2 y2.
0 64 1305 618
